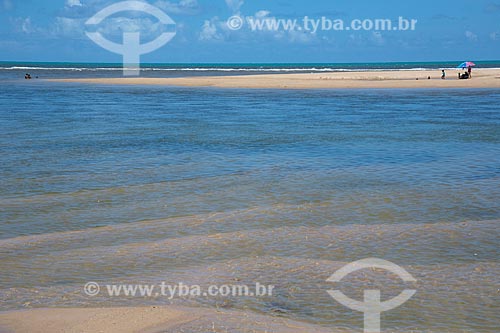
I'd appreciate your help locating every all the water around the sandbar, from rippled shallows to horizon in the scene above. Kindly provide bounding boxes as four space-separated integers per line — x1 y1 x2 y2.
0 63 500 333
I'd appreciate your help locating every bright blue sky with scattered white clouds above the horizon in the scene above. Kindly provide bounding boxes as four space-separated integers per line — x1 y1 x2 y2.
0 0 500 63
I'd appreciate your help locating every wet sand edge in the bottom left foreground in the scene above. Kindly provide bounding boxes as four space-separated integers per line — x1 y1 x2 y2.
0 307 340 333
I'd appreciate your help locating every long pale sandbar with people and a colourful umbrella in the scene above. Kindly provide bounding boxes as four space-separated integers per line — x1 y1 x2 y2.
49 69 500 89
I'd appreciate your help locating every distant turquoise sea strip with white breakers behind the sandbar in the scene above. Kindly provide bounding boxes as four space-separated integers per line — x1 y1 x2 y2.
0 61 500 80
